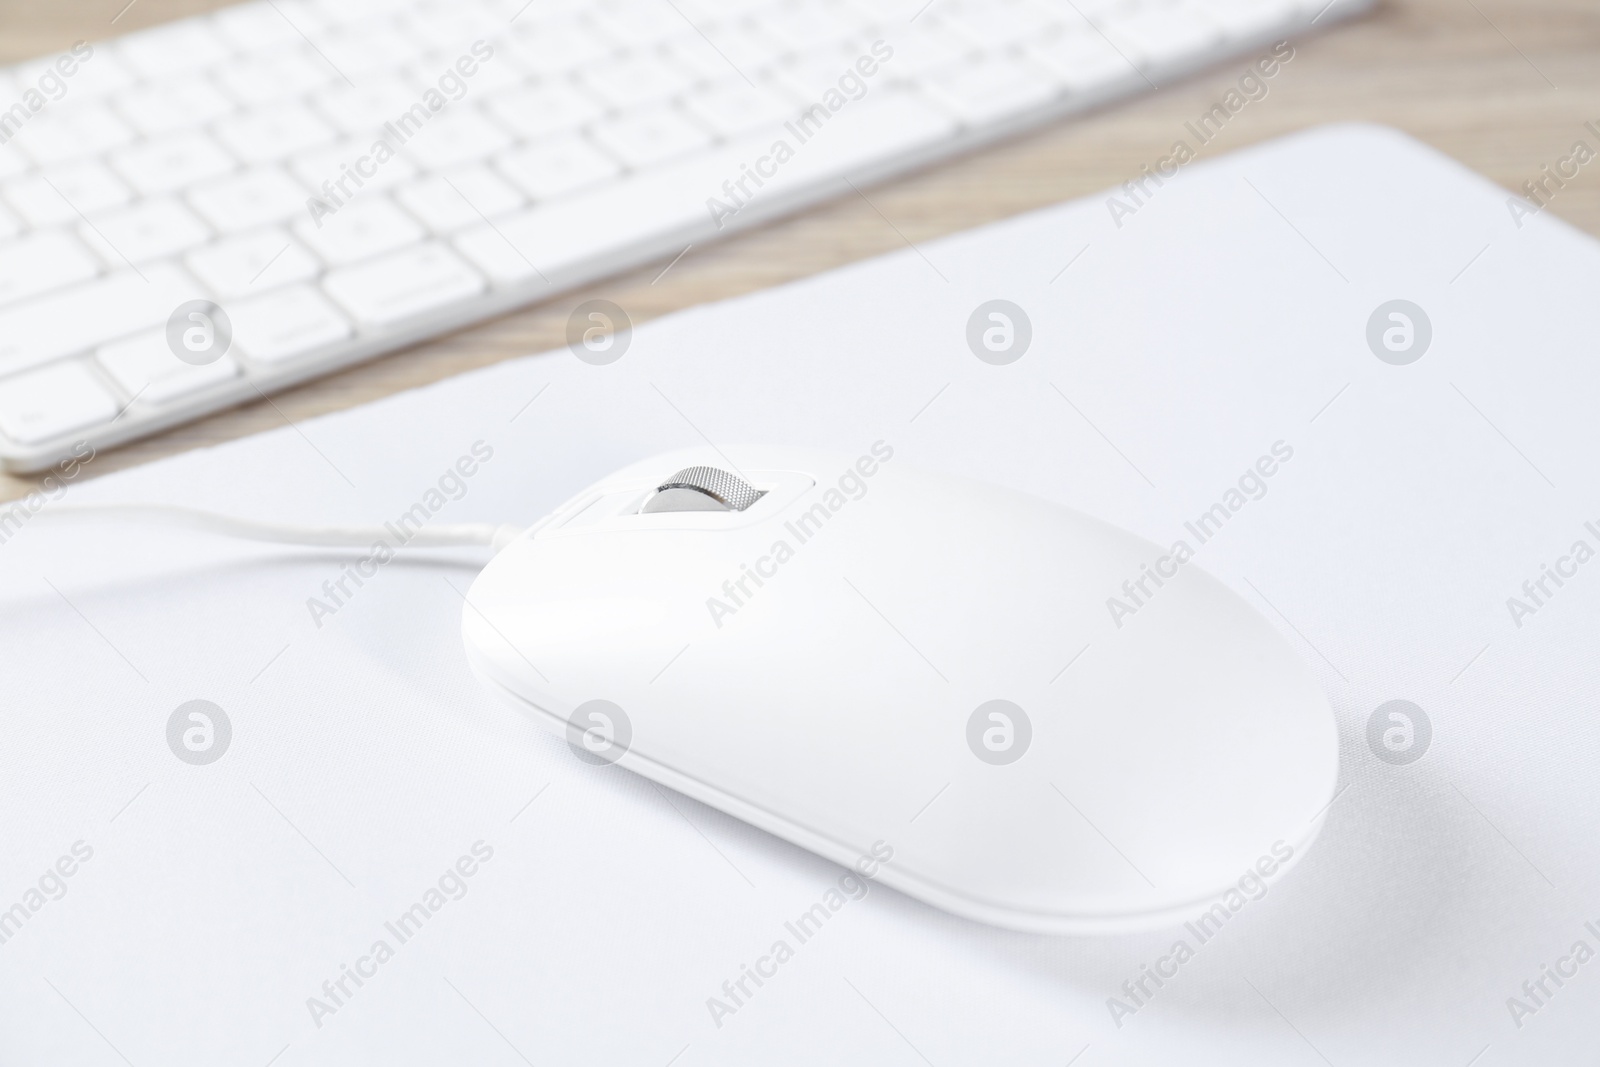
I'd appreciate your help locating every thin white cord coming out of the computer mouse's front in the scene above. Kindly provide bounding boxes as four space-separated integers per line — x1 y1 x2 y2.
35 504 523 552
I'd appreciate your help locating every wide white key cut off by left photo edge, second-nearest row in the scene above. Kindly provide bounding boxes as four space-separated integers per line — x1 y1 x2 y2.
0 262 203 374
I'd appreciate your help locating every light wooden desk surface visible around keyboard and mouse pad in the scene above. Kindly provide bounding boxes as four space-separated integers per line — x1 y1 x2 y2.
0 0 1600 499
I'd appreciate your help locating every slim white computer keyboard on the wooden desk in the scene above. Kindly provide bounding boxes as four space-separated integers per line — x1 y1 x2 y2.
0 0 1366 470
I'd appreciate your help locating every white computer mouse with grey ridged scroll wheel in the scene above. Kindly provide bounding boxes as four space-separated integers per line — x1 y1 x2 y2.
462 442 1338 933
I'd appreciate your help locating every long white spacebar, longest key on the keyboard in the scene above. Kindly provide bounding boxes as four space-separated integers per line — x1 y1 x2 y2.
499 91 955 285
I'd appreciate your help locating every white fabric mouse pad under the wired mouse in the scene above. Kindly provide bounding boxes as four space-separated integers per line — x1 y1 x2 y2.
0 126 1600 1067
